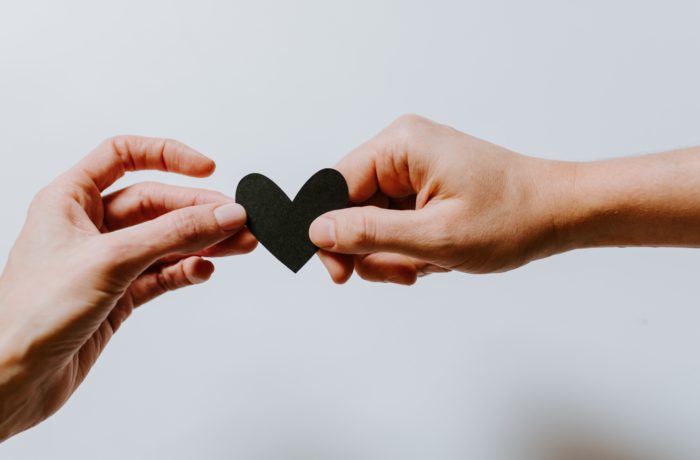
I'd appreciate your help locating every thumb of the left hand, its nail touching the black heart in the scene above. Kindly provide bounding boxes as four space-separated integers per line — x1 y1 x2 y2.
105 202 246 267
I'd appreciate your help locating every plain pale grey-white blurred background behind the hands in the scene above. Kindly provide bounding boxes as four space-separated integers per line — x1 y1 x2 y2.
0 0 700 460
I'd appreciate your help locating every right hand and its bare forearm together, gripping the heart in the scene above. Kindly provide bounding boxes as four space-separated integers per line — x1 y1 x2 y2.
309 115 700 285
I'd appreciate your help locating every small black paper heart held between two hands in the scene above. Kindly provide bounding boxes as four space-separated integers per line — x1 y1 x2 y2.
236 169 348 273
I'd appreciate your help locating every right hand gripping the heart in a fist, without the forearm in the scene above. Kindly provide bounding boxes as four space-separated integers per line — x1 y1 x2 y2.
309 115 576 284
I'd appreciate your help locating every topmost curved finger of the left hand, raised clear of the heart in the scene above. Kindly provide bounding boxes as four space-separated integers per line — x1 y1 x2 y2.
73 136 216 191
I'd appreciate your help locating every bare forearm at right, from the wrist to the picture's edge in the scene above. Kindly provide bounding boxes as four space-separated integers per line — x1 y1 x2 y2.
560 147 700 250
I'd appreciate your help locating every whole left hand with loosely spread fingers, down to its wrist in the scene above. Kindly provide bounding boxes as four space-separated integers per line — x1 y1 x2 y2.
0 136 257 440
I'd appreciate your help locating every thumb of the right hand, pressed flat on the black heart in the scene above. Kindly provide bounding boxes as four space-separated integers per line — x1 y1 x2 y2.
309 206 440 259
